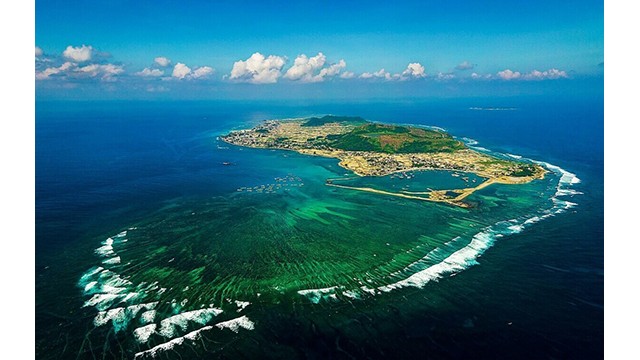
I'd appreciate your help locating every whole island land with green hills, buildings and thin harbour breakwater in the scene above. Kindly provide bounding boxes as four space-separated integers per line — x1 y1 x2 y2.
221 115 546 208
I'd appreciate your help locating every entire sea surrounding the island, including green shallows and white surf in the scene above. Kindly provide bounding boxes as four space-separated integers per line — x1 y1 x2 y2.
35 96 604 359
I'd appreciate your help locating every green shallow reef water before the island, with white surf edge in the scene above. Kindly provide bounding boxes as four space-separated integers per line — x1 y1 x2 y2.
72 146 572 356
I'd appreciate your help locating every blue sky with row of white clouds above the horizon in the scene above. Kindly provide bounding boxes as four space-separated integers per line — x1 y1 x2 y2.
35 0 604 99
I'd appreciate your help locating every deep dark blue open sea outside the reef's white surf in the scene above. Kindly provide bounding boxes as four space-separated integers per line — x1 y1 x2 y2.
35 96 604 359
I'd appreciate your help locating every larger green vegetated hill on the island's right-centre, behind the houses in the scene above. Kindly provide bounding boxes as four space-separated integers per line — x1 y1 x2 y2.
328 123 465 154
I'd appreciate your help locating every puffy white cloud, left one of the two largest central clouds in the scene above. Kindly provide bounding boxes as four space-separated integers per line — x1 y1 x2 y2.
229 52 286 84
